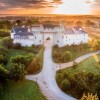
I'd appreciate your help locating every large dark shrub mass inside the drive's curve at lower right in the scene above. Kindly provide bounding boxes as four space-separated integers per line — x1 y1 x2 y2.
56 72 100 100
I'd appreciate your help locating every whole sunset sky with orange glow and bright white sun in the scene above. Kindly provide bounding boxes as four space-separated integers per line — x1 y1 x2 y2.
0 0 100 15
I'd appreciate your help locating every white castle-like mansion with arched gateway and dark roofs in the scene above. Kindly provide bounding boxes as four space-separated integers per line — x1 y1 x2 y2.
11 24 88 47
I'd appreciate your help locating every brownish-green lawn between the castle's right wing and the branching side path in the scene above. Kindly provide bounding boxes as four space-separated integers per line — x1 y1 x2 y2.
52 44 93 63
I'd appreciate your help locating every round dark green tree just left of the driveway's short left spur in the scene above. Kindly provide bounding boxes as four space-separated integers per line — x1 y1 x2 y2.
9 63 26 81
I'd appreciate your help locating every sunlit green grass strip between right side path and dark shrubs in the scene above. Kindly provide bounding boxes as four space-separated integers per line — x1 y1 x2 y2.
57 54 100 75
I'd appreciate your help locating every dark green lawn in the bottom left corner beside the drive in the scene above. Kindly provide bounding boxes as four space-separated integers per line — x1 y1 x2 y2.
0 80 46 100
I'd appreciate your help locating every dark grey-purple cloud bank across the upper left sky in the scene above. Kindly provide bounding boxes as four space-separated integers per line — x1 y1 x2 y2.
0 0 52 10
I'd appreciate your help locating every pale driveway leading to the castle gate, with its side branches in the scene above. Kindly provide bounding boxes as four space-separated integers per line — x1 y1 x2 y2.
26 42 100 100
